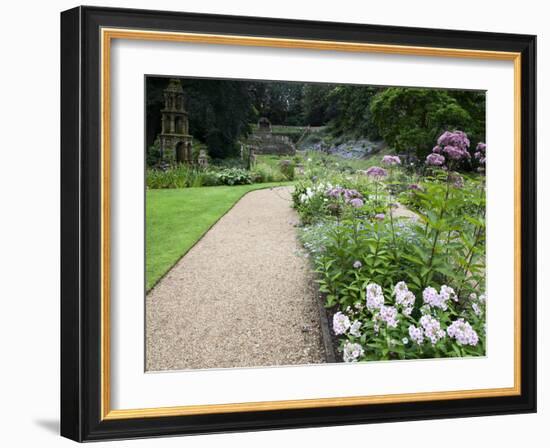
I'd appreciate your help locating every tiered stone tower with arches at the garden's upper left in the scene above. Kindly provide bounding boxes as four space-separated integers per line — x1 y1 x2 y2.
159 79 193 164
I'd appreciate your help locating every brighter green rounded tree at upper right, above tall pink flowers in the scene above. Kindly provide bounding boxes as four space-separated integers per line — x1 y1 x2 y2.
370 87 473 158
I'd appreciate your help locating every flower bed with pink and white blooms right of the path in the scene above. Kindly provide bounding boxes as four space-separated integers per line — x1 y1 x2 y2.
293 131 486 362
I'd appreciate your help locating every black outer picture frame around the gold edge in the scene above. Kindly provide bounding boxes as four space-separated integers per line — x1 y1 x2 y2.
61 7 537 441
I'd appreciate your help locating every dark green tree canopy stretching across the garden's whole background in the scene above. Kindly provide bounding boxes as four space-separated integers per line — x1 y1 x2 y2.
146 77 485 158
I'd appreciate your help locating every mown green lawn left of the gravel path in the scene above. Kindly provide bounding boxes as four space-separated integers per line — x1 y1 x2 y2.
145 182 290 290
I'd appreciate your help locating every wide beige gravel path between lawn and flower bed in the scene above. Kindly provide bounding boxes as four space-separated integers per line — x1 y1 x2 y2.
146 187 325 371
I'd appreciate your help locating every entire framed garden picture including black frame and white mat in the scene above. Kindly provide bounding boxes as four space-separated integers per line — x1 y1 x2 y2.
61 7 536 441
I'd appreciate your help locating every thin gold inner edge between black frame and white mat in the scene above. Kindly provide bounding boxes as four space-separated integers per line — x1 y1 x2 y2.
100 28 521 420
